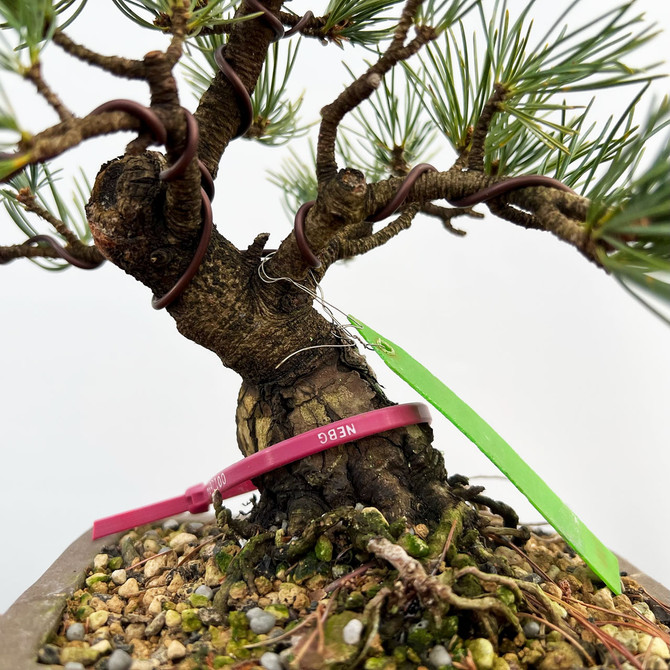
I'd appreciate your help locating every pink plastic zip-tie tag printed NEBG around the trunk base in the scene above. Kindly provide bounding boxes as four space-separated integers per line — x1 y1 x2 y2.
93 403 431 540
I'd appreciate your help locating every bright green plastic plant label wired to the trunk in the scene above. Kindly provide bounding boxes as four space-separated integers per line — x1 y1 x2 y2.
349 315 621 595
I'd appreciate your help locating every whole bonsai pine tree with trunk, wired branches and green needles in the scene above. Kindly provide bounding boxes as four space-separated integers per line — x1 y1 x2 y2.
0 0 670 632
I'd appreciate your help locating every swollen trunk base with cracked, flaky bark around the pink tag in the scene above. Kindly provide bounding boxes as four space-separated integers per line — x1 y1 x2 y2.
237 349 460 532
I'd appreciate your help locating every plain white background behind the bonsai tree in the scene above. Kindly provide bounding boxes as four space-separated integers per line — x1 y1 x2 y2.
0 0 670 611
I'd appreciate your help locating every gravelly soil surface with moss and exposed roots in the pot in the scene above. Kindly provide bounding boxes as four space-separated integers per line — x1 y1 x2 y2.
39 503 670 670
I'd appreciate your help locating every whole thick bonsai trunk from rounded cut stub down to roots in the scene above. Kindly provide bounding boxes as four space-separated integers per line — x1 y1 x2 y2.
88 153 462 529
